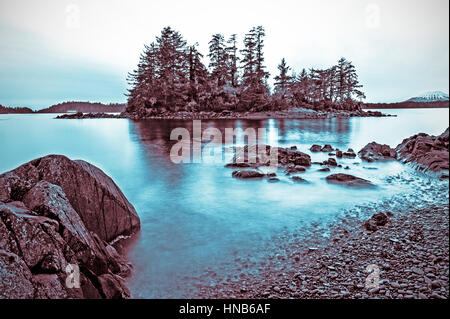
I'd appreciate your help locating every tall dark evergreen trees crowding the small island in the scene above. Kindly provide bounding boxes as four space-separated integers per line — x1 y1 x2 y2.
127 26 365 116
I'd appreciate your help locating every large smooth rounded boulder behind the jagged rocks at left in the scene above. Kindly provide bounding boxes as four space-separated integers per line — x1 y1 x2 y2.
0 155 140 242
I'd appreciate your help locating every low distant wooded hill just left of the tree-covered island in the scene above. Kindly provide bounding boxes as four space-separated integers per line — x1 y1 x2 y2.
37 102 126 113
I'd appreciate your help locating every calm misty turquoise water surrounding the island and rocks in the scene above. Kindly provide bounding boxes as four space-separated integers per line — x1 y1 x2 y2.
0 109 449 298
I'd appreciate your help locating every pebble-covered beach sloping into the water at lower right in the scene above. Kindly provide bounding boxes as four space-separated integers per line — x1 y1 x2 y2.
198 204 449 299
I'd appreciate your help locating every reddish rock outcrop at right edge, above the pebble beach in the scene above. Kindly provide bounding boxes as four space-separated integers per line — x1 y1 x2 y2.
395 128 449 172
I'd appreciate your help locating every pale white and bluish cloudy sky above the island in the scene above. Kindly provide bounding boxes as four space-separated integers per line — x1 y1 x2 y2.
0 0 449 109
